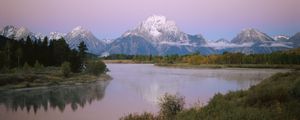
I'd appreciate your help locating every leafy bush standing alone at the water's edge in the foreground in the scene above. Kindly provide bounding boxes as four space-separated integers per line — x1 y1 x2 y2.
159 93 184 120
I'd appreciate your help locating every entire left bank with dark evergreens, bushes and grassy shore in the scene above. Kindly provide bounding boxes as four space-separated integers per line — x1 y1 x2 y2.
0 36 110 90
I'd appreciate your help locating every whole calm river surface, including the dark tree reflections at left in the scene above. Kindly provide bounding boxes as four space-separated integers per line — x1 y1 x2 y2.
0 64 287 120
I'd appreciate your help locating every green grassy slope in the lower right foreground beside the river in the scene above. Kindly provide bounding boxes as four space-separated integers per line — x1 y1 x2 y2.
122 71 300 120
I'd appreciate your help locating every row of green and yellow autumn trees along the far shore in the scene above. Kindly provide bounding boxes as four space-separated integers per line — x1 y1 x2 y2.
103 48 300 65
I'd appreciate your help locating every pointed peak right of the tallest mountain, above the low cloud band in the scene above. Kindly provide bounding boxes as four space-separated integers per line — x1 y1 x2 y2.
231 28 274 44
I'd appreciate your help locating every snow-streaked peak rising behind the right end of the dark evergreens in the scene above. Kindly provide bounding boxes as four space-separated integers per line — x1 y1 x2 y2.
64 26 106 55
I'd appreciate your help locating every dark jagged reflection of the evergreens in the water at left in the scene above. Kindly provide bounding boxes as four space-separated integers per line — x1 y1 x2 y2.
0 81 110 113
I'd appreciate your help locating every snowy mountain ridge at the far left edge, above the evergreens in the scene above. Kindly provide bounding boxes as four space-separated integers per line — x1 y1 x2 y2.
0 25 42 40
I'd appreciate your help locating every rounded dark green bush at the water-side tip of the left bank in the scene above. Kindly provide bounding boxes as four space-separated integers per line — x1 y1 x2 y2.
86 61 107 76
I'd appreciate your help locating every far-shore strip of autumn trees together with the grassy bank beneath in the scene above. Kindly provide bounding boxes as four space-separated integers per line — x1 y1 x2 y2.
103 48 300 69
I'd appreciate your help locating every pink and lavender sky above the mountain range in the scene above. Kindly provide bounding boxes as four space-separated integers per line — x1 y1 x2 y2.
0 0 300 40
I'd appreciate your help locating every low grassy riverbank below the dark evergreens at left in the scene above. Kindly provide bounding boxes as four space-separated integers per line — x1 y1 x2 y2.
0 67 112 90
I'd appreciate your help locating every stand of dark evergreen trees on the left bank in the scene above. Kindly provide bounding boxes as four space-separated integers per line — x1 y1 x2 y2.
0 36 87 72
